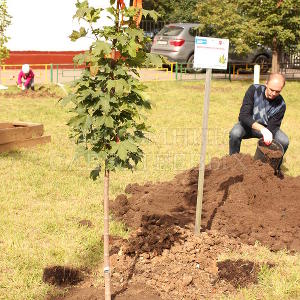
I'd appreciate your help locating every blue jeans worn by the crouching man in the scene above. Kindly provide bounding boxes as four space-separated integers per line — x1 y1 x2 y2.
229 122 289 161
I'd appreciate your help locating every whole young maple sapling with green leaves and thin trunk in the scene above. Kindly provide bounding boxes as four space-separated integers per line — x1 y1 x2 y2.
62 0 161 299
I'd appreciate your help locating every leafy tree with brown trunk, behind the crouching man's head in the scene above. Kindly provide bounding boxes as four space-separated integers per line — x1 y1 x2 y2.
196 0 300 72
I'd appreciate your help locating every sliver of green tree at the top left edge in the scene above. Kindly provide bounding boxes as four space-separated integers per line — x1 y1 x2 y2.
0 0 11 83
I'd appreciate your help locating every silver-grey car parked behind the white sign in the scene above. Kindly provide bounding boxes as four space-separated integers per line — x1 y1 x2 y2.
151 23 272 71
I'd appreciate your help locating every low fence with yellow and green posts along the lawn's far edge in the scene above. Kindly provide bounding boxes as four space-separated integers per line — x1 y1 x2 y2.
0 59 300 85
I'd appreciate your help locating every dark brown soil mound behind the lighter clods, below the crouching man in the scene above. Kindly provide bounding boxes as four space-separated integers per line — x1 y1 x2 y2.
112 154 300 251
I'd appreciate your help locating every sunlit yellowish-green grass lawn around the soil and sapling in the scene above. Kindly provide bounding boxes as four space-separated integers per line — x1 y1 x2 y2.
0 80 300 300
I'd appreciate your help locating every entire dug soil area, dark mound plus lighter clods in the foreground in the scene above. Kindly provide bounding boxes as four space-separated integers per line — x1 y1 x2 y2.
50 154 300 299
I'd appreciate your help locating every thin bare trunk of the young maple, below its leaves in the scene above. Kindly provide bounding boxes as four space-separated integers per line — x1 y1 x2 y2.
103 170 111 300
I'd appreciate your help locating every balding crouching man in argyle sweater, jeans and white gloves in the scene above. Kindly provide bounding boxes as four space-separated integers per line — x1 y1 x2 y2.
229 73 289 173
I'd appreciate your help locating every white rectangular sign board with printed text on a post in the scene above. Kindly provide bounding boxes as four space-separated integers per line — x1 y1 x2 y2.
194 36 229 70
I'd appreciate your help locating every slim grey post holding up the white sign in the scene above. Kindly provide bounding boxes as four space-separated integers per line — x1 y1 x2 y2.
195 69 212 234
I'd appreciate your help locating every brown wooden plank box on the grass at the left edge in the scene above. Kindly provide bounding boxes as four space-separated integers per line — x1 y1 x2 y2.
0 122 51 152
